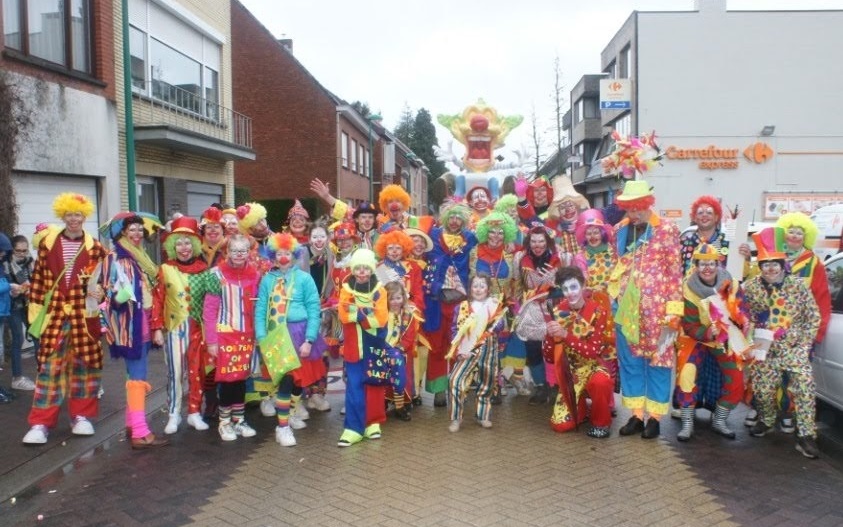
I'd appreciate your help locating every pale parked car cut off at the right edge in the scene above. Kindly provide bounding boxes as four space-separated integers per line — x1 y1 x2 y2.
814 253 843 411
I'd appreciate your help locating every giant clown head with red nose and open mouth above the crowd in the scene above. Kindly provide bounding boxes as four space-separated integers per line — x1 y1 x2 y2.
436 99 524 172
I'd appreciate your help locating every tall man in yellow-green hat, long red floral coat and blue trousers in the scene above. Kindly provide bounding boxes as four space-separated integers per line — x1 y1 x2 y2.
608 180 684 439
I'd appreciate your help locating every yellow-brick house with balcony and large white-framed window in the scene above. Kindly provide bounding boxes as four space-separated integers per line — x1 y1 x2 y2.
123 0 255 219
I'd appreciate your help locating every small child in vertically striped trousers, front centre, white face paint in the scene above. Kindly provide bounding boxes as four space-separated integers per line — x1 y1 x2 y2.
446 275 506 432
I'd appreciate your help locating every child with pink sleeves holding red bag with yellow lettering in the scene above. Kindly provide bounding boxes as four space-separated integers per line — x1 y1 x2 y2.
203 234 260 441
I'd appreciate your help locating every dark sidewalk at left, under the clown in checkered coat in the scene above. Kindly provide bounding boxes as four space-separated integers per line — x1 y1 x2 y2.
0 350 167 503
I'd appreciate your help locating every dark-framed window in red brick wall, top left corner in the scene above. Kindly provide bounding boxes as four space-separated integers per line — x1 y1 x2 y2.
3 0 91 73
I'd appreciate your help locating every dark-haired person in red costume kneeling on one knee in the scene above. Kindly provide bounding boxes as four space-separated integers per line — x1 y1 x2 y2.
547 267 615 439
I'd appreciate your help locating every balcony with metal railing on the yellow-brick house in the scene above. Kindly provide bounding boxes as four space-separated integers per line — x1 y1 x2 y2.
132 80 255 161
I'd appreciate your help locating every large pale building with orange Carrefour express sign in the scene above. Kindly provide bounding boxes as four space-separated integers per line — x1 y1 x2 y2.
585 0 843 226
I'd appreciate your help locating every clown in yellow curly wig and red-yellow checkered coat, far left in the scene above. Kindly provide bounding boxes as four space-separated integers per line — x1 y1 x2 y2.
23 192 106 445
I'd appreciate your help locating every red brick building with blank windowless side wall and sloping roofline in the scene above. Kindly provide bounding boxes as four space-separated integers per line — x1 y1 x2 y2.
231 0 408 228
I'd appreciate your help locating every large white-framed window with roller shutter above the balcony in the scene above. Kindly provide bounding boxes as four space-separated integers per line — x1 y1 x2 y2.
129 0 222 119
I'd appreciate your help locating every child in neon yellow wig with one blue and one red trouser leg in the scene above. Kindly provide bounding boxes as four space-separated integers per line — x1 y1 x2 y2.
337 249 389 447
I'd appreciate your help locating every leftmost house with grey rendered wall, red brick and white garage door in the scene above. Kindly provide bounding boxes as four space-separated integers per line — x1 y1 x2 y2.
0 0 120 236
